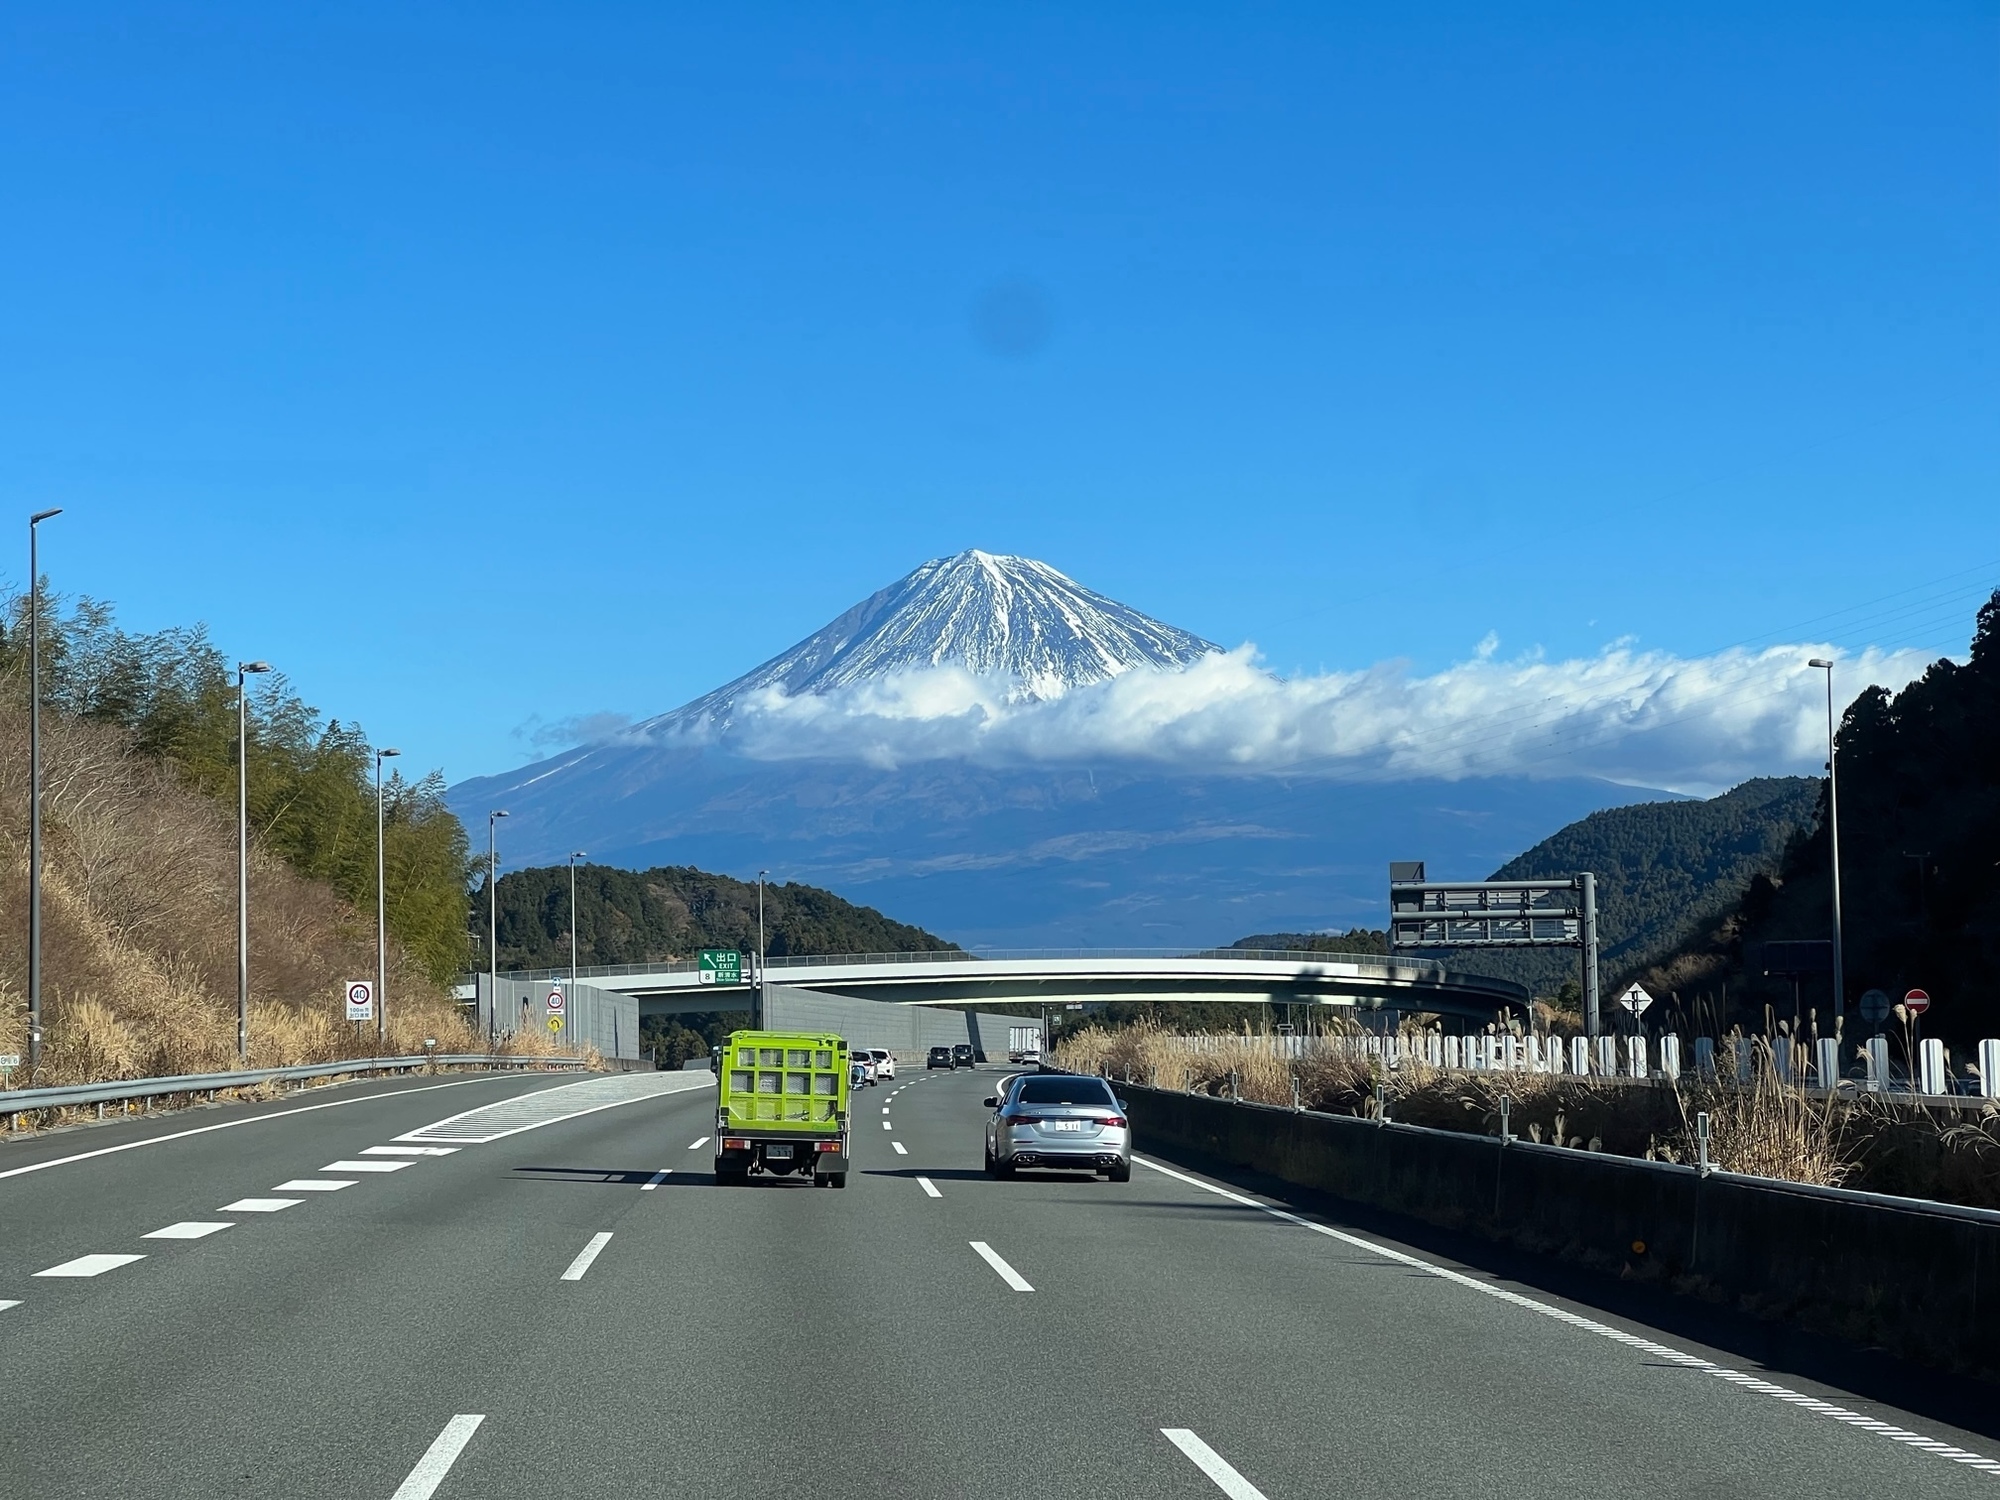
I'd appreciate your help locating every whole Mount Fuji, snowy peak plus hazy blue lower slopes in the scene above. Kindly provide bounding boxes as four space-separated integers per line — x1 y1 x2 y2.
448 550 1670 946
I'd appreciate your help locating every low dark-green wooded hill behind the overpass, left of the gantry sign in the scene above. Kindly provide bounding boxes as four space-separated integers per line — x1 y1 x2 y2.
472 864 958 968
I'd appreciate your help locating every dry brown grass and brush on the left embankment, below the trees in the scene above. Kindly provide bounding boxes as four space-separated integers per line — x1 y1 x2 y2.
0 702 500 1086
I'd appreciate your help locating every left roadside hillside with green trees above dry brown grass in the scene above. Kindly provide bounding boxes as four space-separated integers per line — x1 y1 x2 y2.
0 600 476 1088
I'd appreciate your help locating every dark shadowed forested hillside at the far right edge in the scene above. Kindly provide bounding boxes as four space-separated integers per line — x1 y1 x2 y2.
1642 592 2000 1042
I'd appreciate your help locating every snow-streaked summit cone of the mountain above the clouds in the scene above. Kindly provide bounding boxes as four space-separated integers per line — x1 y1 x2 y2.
638 548 1222 736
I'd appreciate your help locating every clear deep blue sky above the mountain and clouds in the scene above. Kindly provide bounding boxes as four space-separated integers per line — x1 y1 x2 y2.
0 2 2000 780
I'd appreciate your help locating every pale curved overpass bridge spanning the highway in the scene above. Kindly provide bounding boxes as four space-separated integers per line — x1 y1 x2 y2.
502 948 1528 1022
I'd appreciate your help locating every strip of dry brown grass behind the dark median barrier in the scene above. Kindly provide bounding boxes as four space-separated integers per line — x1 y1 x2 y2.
1052 1026 2000 1208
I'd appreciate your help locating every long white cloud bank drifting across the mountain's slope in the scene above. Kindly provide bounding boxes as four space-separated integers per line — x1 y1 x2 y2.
632 642 1932 792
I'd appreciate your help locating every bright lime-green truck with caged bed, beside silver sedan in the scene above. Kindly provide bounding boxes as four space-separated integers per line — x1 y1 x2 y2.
716 1032 848 1188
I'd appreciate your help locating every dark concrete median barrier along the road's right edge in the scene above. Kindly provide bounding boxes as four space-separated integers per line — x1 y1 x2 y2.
1118 1084 2000 1376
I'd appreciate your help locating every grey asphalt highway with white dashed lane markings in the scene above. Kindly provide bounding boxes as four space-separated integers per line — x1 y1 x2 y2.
0 1070 2000 1500
